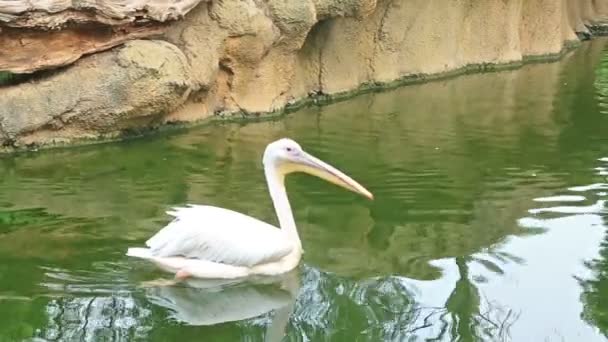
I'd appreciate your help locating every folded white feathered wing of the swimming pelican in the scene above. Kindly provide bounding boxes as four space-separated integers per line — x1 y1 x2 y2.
146 205 294 267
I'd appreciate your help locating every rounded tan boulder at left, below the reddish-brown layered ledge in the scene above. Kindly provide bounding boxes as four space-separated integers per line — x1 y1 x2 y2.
0 40 191 147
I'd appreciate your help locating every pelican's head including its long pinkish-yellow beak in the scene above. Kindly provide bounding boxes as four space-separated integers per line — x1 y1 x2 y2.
264 139 374 199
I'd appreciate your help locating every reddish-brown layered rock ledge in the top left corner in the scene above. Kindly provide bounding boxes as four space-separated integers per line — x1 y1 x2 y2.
0 0 207 73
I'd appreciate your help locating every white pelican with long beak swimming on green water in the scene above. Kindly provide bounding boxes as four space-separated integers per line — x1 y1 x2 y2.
127 138 373 279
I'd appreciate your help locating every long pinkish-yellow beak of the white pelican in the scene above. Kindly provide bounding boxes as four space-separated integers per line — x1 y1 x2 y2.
284 151 374 200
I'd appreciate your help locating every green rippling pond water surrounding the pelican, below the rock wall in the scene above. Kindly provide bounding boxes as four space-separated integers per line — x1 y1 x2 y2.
0 40 608 341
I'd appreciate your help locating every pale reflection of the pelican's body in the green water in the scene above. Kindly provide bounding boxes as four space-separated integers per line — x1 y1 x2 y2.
146 272 300 325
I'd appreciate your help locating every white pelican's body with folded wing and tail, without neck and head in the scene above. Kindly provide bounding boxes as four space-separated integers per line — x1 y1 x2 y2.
127 205 302 279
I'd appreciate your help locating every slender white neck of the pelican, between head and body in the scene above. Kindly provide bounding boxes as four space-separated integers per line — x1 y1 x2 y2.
264 164 302 249
